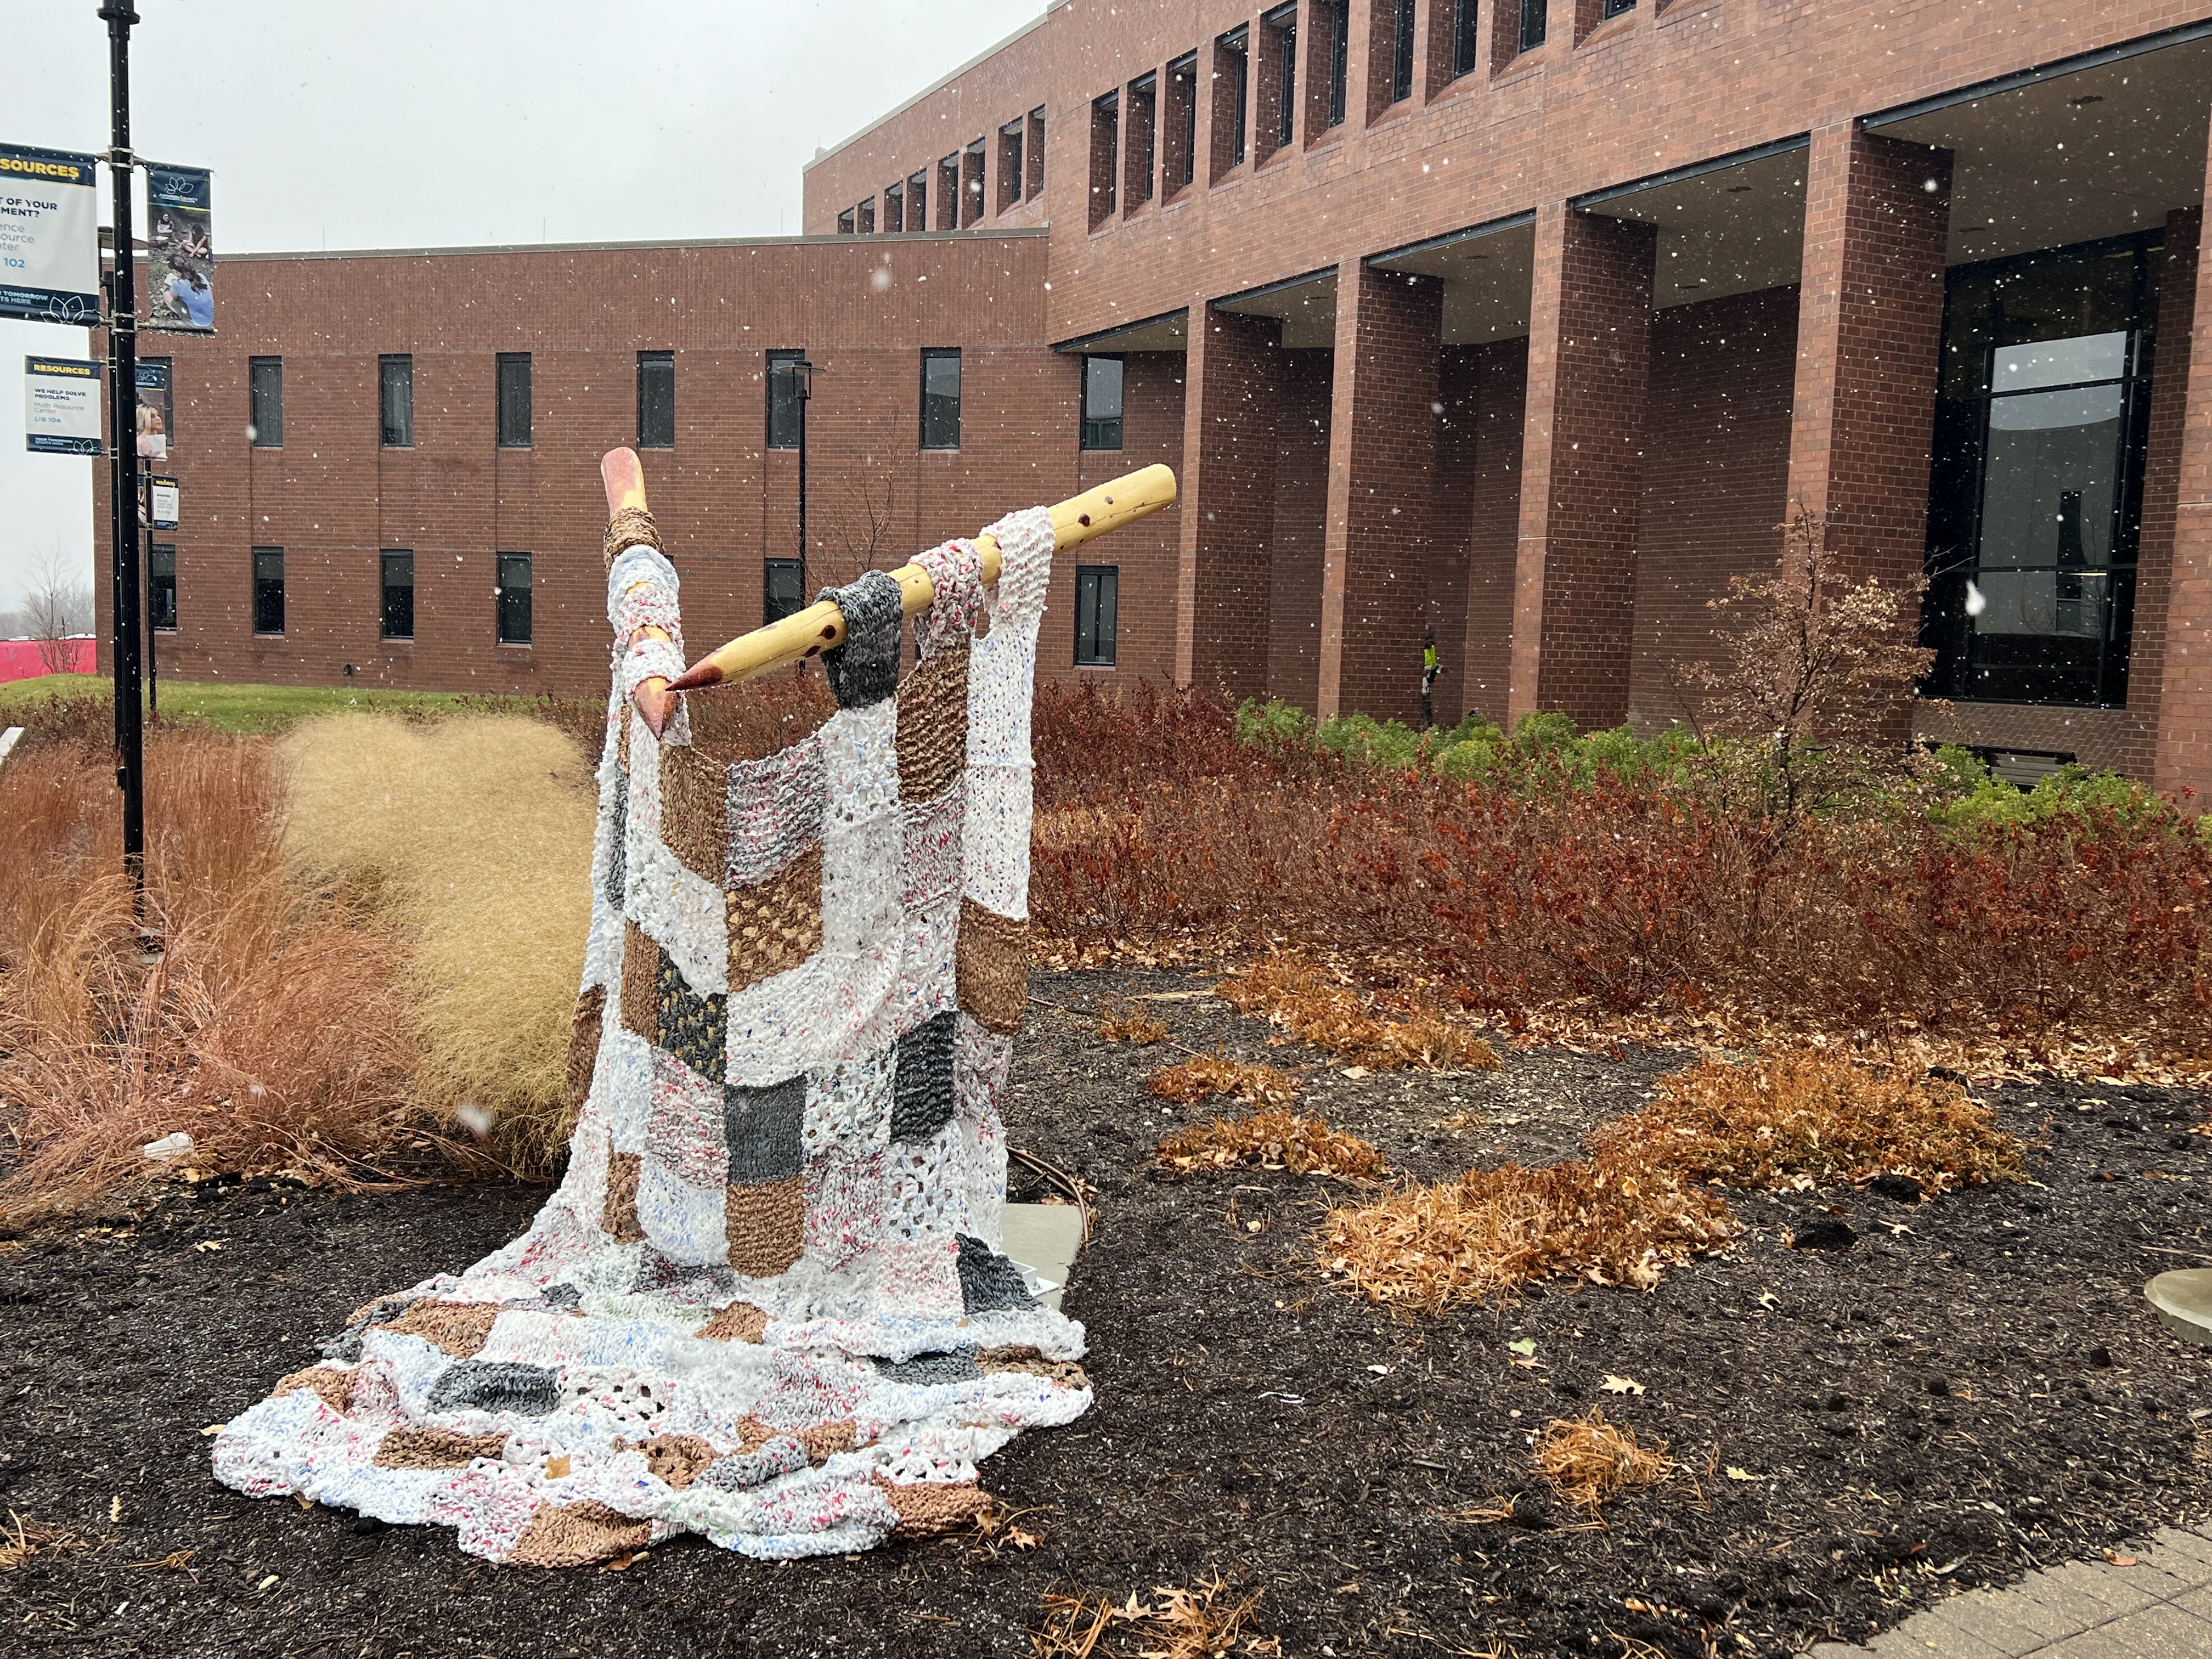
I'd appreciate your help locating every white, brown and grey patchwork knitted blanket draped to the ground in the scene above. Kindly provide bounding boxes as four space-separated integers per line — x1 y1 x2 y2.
215 509 1091 1566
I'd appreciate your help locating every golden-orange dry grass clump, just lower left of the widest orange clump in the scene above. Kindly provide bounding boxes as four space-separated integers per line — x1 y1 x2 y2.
1318 1161 1743 1314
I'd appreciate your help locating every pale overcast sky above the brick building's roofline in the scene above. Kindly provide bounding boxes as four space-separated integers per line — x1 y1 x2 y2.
0 0 1044 608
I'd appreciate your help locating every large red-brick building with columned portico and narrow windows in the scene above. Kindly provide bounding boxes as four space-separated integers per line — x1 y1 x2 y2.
99 0 2212 787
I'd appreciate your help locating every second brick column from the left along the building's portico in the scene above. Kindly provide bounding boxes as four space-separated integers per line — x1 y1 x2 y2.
1316 259 1444 725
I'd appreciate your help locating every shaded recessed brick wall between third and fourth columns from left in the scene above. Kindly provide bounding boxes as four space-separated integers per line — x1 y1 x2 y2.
1628 287 1798 730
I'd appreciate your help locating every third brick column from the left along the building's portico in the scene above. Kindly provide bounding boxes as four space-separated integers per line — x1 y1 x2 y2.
1506 204 1659 730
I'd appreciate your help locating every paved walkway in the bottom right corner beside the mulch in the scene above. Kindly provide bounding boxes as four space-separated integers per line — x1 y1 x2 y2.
1812 1526 2212 1659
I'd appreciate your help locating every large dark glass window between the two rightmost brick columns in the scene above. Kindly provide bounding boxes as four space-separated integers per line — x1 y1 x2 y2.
1920 232 2163 706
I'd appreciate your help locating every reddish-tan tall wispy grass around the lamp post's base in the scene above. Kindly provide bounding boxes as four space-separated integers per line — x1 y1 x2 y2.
0 730 411 1215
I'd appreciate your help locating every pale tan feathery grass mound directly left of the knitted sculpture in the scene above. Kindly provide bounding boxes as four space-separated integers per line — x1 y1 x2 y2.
283 714 597 1170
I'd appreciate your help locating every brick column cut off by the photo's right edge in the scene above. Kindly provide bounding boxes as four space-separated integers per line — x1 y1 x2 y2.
2130 126 2212 808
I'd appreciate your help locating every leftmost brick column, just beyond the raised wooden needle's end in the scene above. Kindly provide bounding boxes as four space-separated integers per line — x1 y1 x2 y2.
1175 303 1283 697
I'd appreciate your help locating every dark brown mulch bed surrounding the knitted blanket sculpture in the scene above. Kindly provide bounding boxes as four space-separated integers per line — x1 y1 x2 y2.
0 973 2212 1659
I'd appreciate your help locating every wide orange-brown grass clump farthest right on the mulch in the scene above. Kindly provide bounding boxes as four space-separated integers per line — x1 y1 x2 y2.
1588 1048 2026 1192
